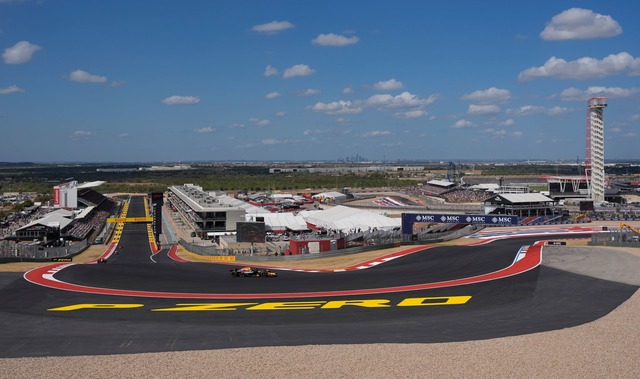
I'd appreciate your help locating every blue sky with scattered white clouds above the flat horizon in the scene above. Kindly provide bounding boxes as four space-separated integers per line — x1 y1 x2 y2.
0 0 640 162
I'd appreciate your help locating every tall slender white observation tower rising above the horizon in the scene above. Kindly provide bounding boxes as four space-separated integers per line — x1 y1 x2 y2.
585 97 607 201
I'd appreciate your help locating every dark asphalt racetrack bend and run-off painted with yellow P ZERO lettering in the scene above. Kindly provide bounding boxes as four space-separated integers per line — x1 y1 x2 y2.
0 198 638 357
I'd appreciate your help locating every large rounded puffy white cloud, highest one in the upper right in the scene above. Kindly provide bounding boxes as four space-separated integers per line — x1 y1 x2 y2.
540 8 622 40
